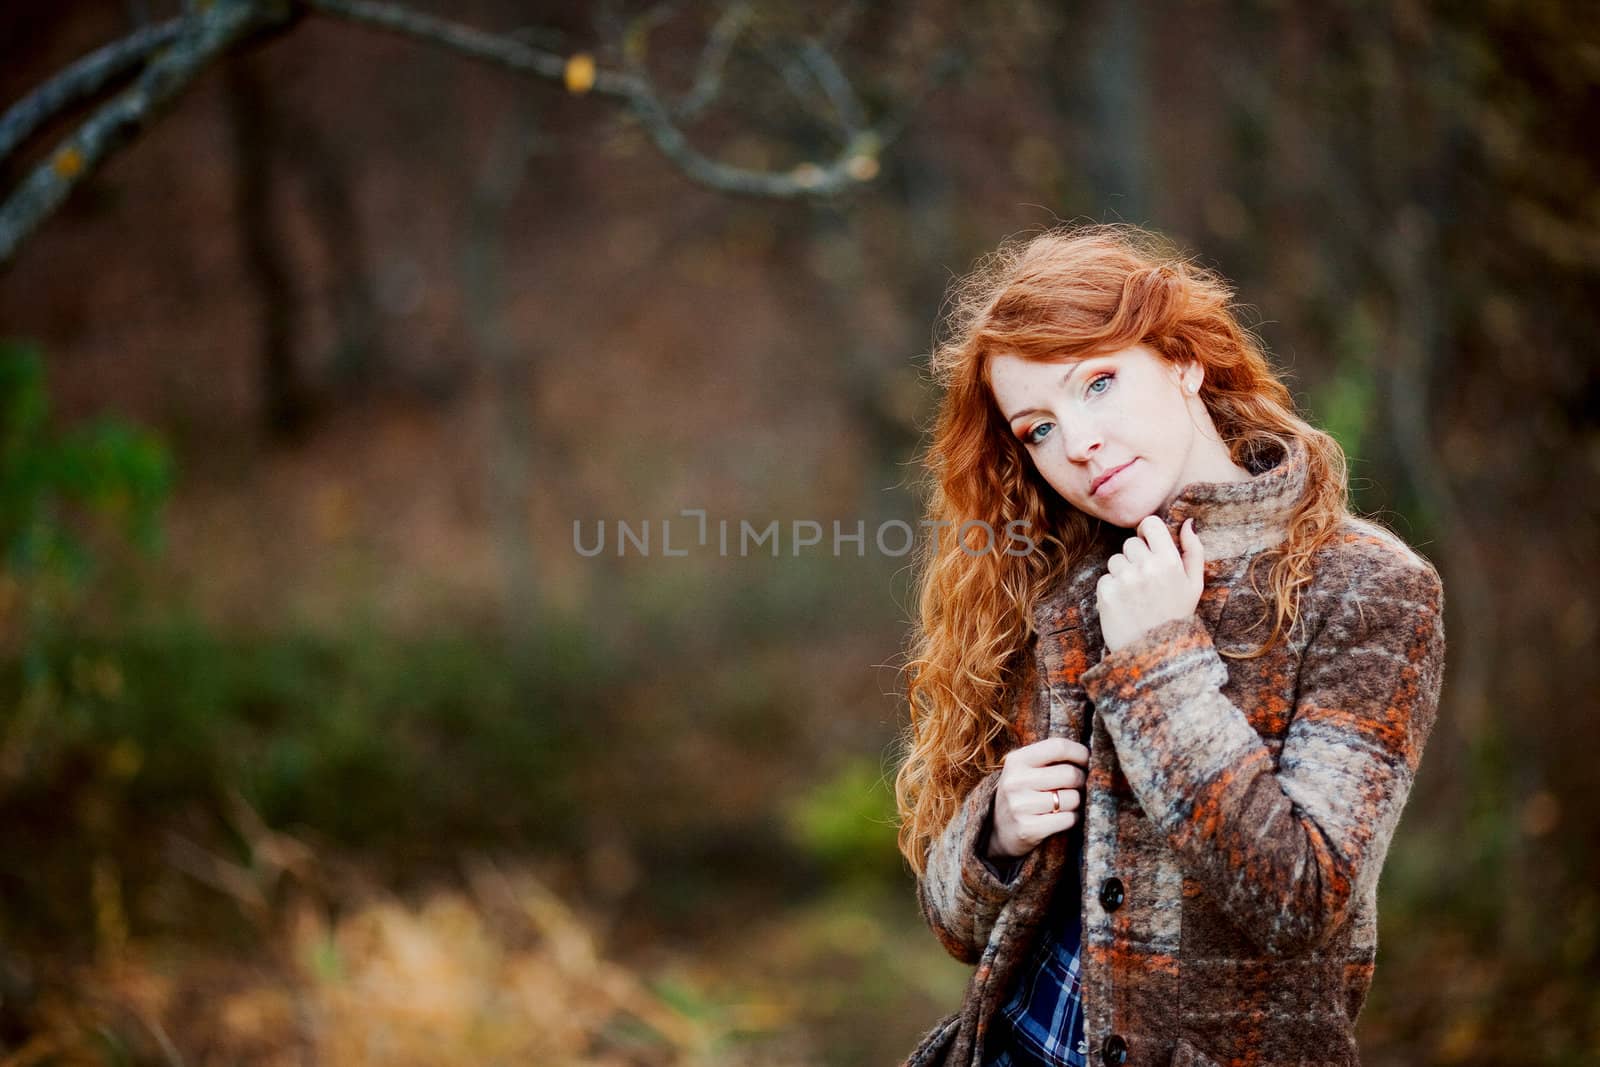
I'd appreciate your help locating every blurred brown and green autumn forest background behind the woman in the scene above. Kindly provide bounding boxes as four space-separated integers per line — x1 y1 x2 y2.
0 0 1600 1067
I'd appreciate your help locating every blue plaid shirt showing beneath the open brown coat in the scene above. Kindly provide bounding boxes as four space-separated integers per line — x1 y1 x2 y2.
984 827 1088 1067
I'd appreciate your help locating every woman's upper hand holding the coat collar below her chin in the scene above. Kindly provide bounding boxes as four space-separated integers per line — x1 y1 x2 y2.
1096 515 1205 651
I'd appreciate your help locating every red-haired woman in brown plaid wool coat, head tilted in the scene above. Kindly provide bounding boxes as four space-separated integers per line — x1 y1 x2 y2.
896 226 1445 1067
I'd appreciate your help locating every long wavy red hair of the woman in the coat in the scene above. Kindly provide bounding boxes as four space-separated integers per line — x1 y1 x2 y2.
894 224 1349 875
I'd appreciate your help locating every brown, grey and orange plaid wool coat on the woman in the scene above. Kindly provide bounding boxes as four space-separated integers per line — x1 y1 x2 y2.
906 443 1445 1067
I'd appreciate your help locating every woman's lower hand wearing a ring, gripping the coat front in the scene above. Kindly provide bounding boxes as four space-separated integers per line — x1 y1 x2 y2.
989 737 1090 859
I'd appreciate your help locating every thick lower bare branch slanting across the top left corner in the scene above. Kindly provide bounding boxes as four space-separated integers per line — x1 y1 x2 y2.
0 0 291 262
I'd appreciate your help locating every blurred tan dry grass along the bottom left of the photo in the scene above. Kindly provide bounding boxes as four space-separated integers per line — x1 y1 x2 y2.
0 859 811 1067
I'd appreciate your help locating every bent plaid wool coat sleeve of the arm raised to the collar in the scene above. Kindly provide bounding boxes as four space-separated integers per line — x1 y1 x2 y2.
1083 550 1445 955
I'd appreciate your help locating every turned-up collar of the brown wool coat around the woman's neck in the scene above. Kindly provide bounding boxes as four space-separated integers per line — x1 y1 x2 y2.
1034 438 1307 633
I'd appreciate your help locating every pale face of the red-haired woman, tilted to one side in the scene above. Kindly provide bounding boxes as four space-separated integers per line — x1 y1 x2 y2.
989 344 1235 528
